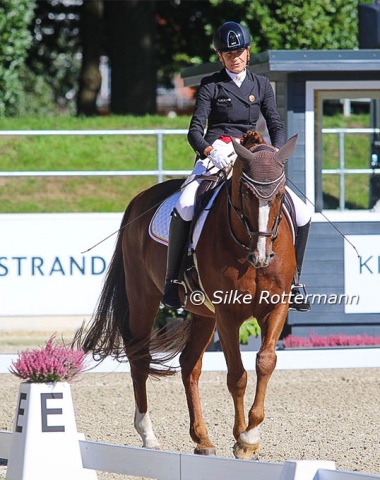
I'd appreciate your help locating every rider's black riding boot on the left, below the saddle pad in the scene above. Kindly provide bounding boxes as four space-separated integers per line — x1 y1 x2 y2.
161 209 191 310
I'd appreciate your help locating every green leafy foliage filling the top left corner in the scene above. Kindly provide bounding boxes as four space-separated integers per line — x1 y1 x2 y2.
0 0 34 116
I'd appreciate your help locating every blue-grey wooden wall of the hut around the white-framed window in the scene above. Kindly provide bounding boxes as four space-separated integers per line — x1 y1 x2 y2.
284 72 380 336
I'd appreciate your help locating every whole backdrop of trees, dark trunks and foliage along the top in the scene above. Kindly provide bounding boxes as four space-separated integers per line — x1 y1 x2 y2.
0 0 372 115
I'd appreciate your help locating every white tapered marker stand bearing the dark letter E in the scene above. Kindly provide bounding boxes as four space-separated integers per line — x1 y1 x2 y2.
7 382 97 480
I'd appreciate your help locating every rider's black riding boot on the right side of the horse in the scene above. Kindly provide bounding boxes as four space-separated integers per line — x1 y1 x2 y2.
289 222 311 312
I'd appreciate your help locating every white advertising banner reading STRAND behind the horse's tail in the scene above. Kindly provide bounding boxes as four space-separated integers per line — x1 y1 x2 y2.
0 213 122 317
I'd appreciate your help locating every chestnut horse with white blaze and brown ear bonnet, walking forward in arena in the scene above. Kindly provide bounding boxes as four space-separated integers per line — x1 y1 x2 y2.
79 132 297 459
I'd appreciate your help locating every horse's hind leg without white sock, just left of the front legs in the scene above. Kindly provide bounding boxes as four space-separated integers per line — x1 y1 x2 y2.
180 314 216 455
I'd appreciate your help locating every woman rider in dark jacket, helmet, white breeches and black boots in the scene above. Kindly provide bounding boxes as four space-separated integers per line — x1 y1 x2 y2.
162 22 310 311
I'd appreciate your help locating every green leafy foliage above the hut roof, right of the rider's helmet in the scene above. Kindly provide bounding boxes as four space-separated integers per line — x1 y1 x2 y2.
212 0 371 53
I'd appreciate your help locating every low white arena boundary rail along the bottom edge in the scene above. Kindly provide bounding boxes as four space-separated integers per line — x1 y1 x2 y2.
0 431 380 480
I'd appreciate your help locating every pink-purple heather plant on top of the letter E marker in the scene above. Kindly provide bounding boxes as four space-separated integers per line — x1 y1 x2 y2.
9 335 86 383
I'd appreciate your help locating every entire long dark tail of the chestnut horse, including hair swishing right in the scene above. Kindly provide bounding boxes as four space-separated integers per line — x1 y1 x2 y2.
73 193 190 377
